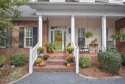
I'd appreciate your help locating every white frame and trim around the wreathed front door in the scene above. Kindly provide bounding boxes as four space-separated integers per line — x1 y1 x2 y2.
49 26 66 51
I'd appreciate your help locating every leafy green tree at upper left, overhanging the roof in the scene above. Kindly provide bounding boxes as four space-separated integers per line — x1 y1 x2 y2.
0 0 27 48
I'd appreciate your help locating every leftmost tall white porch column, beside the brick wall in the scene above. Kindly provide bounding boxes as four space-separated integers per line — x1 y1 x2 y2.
38 16 43 46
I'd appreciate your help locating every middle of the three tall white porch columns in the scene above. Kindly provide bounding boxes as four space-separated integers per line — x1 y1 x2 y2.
71 16 75 43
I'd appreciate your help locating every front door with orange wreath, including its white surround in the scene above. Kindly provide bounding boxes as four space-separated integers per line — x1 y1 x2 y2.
51 27 66 51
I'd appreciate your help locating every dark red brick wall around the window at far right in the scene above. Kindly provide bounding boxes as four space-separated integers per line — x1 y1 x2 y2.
116 18 125 52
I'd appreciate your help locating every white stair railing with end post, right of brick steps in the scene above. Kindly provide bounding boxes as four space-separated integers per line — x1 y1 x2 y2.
72 43 79 73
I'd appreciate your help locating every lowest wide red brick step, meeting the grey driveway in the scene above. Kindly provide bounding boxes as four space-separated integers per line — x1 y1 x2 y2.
33 65 74 72
